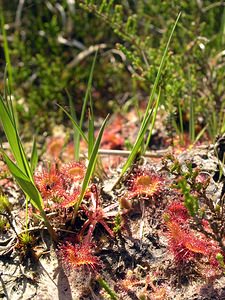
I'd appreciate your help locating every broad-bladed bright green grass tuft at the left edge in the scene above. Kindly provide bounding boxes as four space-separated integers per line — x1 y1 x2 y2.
0 81 56 240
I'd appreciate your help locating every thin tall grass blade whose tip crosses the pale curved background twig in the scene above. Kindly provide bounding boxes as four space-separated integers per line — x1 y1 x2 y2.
75 51 98 160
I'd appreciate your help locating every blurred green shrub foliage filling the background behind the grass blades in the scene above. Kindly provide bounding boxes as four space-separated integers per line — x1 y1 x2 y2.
1 0 225 139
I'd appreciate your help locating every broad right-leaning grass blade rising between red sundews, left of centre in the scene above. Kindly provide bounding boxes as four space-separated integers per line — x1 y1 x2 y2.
77 115 109 209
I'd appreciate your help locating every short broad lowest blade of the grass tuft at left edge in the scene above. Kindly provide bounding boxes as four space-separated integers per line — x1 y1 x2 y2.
1 151 43 210
